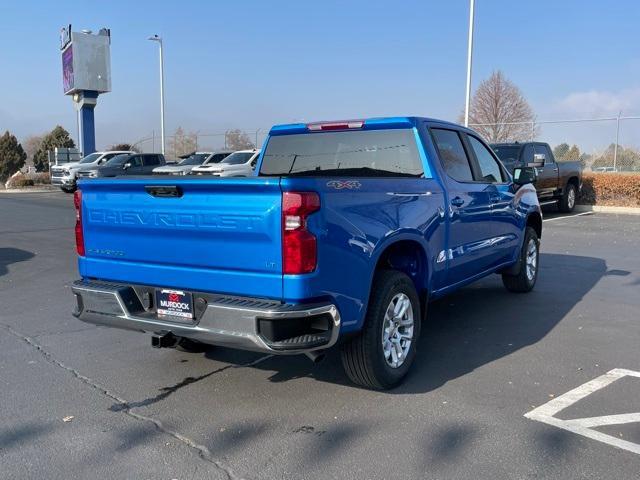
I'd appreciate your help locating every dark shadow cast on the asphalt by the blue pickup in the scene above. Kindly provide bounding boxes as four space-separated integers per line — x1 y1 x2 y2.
244 254 608 394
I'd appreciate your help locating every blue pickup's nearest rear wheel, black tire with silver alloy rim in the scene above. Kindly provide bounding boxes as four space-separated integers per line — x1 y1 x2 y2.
342 270 421 390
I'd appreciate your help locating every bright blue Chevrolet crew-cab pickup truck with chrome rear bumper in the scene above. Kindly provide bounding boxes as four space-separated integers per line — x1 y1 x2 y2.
72 117 542 389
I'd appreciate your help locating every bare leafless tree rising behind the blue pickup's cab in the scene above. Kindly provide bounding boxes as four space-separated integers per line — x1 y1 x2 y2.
459 70 537 142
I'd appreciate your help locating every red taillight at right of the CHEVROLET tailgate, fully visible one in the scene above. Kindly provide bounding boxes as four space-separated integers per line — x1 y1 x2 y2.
282 192 320 275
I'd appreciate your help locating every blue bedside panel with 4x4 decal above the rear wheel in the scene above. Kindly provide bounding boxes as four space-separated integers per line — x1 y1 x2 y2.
281 178 445 332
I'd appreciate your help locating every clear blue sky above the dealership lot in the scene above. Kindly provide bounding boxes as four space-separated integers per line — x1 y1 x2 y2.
0 0 640 151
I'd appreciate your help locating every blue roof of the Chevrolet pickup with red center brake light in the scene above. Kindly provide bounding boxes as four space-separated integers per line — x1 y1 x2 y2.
269 117 471 135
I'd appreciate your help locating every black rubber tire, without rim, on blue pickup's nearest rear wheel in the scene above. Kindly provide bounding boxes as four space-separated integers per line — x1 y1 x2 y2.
342 270 421 390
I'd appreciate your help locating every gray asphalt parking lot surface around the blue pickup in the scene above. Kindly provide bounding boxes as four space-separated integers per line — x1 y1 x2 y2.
0 193 640 479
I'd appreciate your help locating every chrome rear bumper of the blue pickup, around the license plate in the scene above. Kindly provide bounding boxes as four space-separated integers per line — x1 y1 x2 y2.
71 280 341 355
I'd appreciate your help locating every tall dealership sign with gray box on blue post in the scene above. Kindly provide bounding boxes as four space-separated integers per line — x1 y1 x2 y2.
60 25 111 155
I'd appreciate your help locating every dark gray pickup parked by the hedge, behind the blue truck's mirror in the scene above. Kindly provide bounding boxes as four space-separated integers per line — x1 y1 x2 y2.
491 142 582 212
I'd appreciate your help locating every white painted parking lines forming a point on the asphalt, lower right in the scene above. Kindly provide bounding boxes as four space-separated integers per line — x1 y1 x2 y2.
524 368 640 455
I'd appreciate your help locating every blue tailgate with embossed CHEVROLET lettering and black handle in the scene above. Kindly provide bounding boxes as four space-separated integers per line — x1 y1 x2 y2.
79 177 282 299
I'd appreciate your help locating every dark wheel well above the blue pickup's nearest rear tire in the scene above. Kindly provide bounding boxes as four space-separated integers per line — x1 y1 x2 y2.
376 240 427 298
